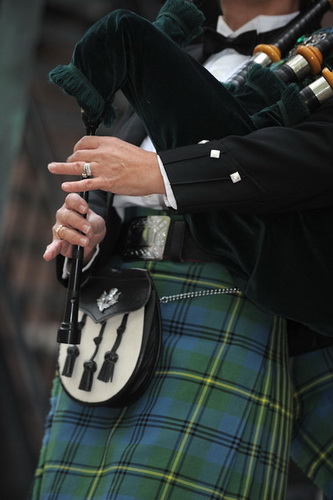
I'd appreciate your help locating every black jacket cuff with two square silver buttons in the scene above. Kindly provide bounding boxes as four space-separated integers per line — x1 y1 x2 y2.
159 141 263 213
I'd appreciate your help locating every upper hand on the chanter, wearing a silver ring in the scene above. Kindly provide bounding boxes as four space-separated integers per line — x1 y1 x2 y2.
48 136 165 196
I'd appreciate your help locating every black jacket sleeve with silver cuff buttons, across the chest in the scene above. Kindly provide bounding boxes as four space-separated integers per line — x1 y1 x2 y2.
159 99 333 213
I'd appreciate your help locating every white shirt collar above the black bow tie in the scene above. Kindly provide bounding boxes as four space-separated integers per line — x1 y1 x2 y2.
216 12 298 36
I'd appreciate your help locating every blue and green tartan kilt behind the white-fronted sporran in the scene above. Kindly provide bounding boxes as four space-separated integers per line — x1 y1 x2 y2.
32 262 293 500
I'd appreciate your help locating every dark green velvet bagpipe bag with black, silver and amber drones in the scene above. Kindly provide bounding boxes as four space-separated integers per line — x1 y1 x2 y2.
49 0 333 136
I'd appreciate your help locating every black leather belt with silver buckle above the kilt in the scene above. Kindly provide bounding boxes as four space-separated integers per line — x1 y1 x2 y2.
119 215 213 262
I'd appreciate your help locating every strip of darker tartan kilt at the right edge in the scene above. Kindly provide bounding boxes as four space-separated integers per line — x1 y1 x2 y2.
291 347 333 500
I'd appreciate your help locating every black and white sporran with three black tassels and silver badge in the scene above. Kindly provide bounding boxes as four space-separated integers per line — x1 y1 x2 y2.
58 269 161 407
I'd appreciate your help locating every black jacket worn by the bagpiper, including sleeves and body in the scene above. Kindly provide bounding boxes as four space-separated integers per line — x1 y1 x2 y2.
60 42 333 335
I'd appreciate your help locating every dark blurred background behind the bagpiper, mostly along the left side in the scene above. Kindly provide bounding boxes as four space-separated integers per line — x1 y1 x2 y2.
0 0 331 500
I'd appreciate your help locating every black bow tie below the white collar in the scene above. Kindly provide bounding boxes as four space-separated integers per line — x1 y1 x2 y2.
203 28 284 57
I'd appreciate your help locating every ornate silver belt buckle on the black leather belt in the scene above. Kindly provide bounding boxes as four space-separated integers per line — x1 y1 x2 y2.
123 215 171 260
